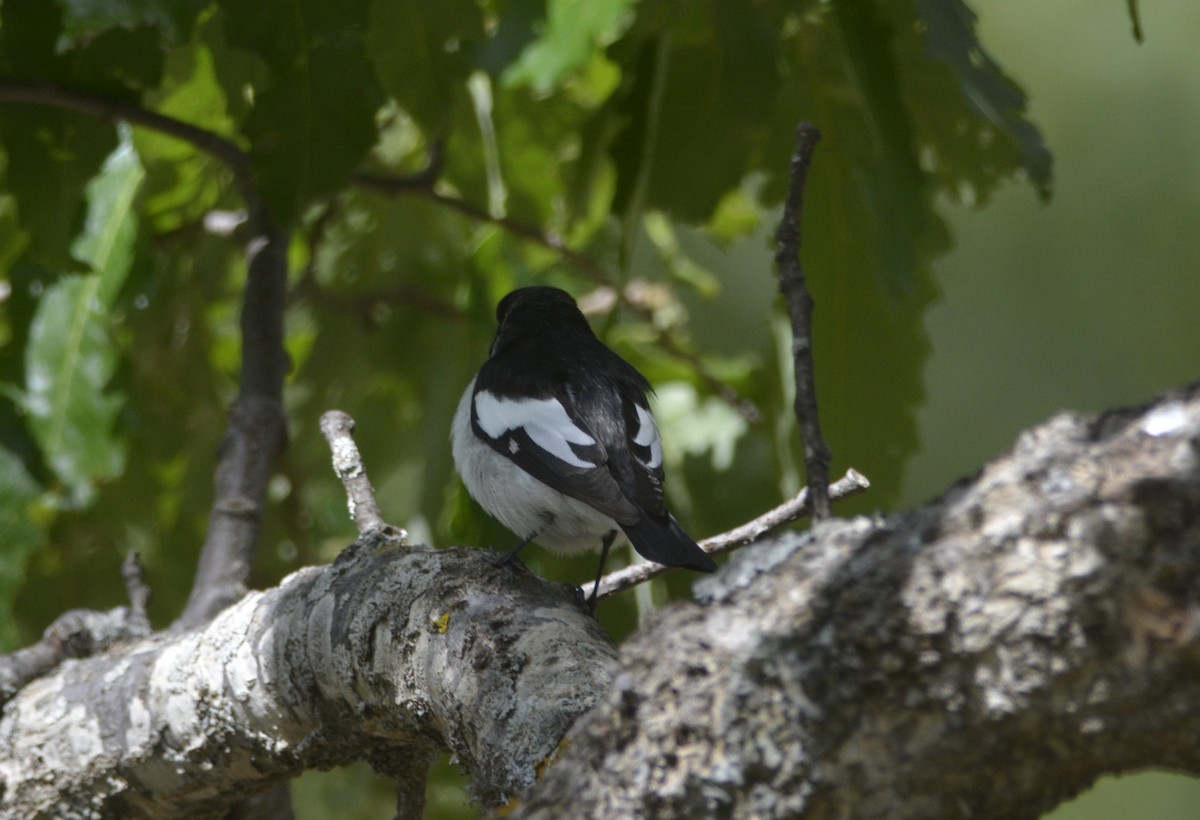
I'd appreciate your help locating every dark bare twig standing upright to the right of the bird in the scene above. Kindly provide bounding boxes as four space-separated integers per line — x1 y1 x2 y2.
775 122 833 521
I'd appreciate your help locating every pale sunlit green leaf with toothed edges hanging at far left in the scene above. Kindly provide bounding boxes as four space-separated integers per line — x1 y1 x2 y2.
24 144 143 504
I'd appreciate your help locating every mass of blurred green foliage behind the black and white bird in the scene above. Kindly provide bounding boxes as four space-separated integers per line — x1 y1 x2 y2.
0 0 1190 816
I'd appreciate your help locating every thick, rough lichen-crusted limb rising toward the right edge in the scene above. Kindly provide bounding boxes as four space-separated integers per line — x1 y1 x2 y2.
517 384 1200 819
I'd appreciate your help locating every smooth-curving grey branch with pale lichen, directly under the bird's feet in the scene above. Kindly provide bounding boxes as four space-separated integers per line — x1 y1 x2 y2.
0 533 614 818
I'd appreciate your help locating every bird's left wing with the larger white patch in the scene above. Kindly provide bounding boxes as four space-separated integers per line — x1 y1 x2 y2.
470 384 643 525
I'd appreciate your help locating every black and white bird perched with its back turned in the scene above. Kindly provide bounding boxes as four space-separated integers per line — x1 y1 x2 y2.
450 287 716 605
